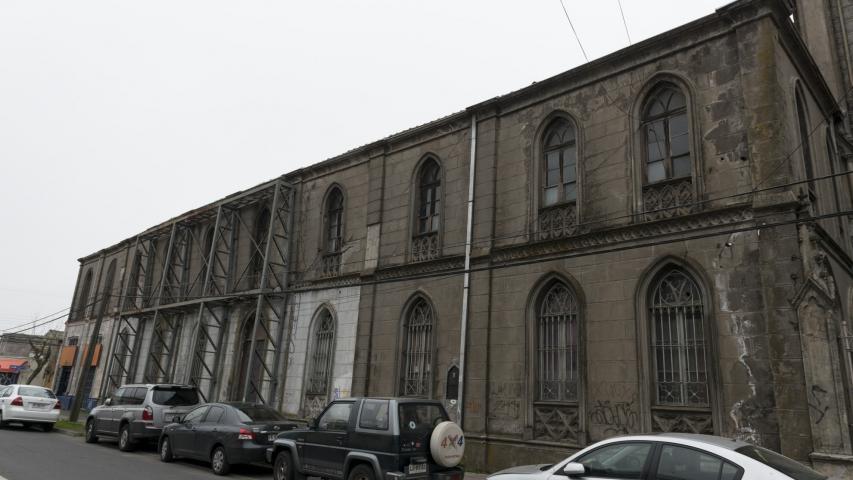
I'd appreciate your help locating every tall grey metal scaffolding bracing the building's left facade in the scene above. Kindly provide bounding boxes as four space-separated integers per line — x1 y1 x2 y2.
100 179 295 403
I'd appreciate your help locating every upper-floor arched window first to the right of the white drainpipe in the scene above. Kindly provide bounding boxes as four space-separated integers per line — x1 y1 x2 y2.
542 118 578 207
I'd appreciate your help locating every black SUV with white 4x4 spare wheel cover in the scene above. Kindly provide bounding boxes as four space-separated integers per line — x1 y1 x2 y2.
266 398 465 480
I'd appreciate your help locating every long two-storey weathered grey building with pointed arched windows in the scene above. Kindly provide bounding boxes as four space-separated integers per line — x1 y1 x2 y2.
61 0 853 478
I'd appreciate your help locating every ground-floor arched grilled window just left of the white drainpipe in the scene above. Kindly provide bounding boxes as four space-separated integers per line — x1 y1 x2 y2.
400 297 435 397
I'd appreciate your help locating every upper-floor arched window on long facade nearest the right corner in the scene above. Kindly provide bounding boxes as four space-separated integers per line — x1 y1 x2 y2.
642 83 693 184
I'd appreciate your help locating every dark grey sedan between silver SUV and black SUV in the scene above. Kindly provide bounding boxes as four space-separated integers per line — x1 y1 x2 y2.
158 403 297 475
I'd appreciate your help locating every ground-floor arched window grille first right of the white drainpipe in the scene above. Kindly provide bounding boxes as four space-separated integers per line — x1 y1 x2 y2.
536 282 578 402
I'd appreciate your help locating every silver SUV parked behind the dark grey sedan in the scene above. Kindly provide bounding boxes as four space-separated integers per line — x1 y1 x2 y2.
86 384 202 452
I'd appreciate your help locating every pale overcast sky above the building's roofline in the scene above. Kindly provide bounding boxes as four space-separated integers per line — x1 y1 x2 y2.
0 0 728 331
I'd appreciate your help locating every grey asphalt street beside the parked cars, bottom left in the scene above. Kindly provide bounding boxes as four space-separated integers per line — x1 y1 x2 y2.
0 425 272 480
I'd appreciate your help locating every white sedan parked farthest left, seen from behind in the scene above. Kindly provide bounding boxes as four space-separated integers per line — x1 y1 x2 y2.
0 385 60 432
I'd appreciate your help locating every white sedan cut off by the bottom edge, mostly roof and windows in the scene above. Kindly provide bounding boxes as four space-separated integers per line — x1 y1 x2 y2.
489 433 826 480
